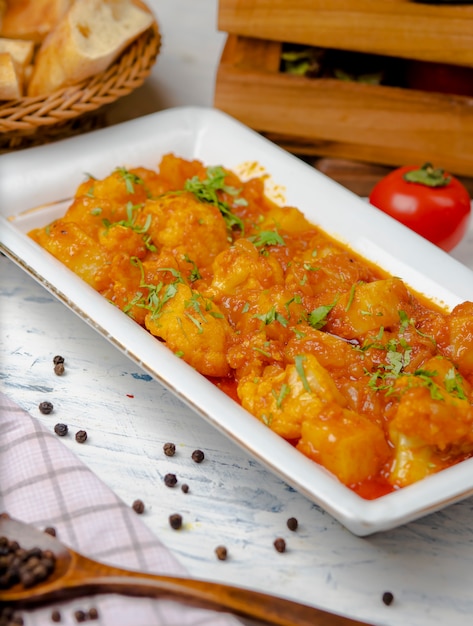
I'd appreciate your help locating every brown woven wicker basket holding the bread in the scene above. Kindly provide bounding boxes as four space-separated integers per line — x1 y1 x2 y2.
0 23 161 152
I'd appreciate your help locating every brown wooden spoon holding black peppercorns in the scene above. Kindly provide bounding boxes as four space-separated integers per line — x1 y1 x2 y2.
0 515 367 626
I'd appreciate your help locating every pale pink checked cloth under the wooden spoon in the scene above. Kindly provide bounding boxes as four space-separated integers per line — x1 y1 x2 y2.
0 393 242 626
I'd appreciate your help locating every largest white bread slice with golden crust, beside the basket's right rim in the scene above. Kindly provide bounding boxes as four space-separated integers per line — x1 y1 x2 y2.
28 0 154 96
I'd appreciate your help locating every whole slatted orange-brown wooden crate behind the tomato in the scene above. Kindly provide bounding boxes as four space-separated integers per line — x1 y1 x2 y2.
214 0 473 176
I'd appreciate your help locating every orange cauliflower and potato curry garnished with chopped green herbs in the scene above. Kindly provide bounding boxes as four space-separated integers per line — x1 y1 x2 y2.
29 154 473 499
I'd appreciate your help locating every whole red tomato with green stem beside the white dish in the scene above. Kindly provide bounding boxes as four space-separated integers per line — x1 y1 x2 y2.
369 163 471 252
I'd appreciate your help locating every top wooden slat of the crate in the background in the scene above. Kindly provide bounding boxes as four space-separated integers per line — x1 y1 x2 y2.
218 0 473 66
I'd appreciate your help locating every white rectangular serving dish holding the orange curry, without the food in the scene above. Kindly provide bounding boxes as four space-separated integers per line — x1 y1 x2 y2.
0 107 473 536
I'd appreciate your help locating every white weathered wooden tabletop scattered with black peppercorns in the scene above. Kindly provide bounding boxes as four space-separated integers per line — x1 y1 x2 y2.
0 0 473 626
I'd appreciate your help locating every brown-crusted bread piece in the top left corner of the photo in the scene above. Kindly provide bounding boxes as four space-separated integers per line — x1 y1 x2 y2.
0 0 74 43
